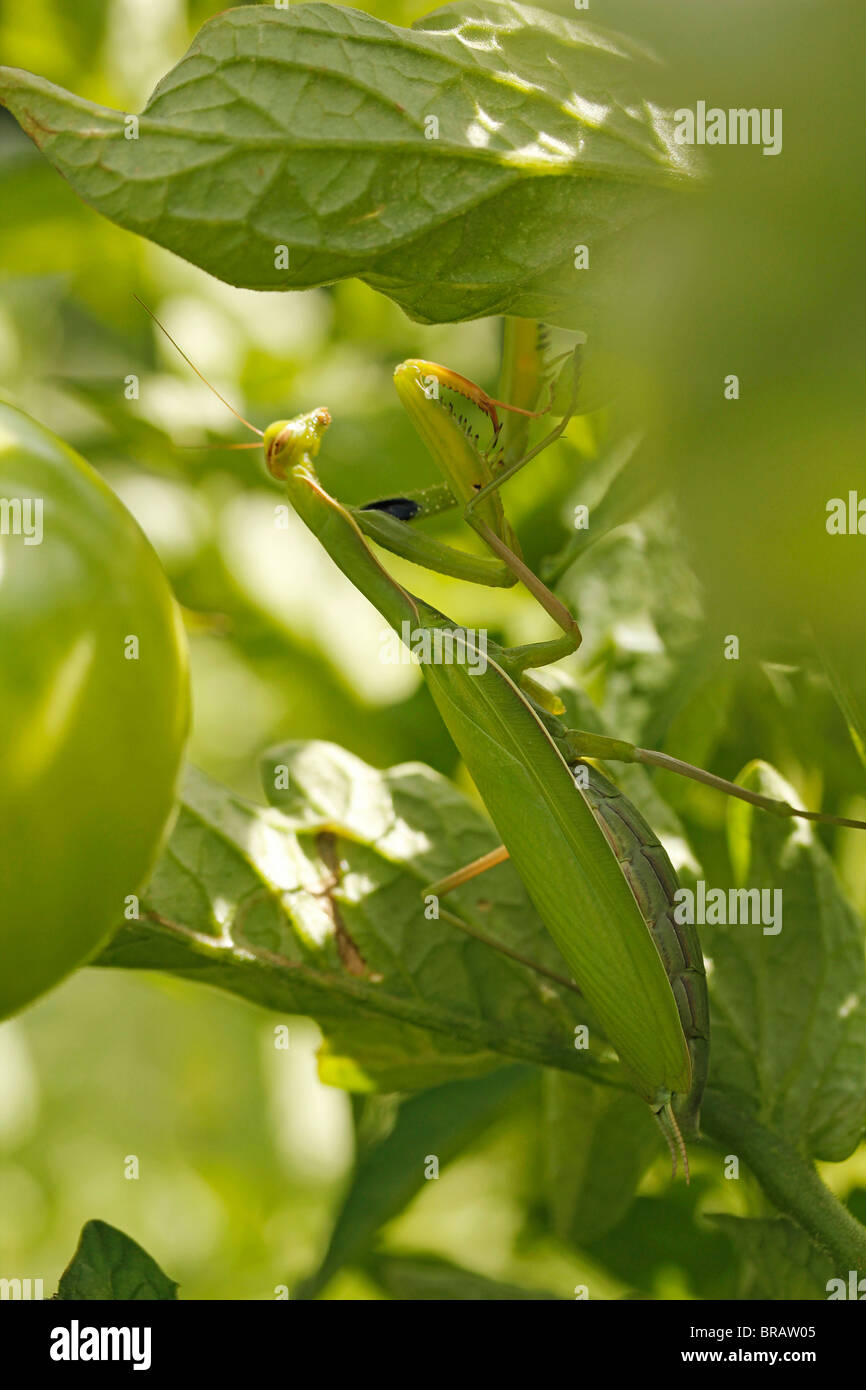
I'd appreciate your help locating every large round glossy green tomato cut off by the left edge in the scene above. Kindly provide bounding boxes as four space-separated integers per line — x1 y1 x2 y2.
0 403 189 1017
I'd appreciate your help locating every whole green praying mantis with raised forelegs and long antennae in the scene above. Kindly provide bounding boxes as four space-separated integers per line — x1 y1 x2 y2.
136 306 866 1180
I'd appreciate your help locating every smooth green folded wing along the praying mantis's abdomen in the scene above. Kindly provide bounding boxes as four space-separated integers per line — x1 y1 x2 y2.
416 650 692 1113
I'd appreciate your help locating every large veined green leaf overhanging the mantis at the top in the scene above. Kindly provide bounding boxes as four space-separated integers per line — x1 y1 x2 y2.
0 3 695 328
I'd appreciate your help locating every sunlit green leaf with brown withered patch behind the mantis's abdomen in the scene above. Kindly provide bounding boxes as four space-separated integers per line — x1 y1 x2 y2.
97 742 624 1090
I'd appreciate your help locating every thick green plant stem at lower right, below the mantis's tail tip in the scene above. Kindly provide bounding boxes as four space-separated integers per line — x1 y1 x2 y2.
701 1091 866 1275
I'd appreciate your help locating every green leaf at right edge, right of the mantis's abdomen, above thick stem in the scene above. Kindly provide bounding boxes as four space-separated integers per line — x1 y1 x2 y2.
699 763 866 1161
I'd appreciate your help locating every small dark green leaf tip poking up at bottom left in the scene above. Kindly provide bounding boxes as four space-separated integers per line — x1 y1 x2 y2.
57 1220 178 1302
